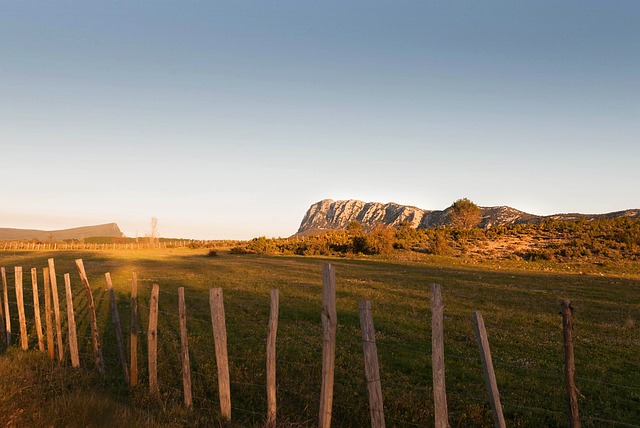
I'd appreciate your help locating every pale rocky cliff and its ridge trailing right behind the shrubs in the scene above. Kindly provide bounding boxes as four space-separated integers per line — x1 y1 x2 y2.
297 199 640 235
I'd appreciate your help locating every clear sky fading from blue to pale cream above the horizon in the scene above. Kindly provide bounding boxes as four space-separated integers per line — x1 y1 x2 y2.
0 0 640 239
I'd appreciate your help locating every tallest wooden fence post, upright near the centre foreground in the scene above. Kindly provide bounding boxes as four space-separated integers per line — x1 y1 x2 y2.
318 263 337 428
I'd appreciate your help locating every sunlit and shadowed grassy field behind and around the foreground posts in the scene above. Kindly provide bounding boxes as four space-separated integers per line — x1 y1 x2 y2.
0 249 640 427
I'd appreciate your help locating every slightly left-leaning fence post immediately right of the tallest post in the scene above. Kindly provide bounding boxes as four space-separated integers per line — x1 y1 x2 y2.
358 300 385 428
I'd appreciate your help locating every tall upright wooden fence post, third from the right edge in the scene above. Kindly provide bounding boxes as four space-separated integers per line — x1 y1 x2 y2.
431 284 449 428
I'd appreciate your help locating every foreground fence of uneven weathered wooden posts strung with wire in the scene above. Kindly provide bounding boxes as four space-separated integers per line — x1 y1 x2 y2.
0 259 640 427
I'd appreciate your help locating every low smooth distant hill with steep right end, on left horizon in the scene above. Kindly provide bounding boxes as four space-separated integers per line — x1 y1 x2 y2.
0 223 124 241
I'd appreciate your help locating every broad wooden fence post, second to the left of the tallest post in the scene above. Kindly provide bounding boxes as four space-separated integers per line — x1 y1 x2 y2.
209 288 231 420
